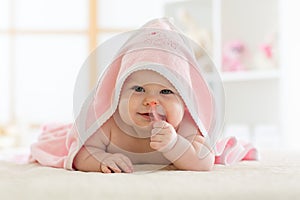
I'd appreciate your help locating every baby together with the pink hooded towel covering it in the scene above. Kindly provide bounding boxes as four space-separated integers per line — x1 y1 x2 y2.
30 19 256 173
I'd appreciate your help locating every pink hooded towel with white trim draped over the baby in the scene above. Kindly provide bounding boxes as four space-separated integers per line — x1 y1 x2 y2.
30 19 257 170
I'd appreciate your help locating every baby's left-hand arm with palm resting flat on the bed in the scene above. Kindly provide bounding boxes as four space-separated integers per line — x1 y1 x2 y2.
74 121 132 173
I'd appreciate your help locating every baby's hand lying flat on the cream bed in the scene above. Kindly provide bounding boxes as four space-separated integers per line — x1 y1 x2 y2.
100 153 133 173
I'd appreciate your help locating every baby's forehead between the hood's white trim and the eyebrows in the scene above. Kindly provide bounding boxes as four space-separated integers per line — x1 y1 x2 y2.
126 70 173 88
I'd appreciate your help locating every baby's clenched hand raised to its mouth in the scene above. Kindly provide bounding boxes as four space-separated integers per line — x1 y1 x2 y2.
150 121 177 152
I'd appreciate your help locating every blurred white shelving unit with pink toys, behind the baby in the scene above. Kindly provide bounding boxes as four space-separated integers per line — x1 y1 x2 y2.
165 0 282 138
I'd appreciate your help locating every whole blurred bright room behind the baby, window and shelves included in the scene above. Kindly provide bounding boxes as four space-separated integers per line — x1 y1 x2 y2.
0 0 300 158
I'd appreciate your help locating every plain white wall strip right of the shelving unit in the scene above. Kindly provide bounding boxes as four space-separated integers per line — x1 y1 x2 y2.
280 0 300 150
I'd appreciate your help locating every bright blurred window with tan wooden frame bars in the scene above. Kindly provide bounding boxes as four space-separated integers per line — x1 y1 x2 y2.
0 0 175 130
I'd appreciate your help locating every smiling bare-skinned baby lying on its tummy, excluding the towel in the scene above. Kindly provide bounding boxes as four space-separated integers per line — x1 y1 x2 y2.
74 70 214 173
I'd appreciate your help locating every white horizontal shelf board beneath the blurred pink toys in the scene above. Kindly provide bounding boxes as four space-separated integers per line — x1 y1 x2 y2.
221 69 280 83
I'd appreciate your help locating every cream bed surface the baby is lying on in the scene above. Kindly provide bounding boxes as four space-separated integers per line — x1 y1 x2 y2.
0 152 300 200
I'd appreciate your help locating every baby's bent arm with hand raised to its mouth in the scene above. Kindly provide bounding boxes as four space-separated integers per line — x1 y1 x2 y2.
150 122 215 171
